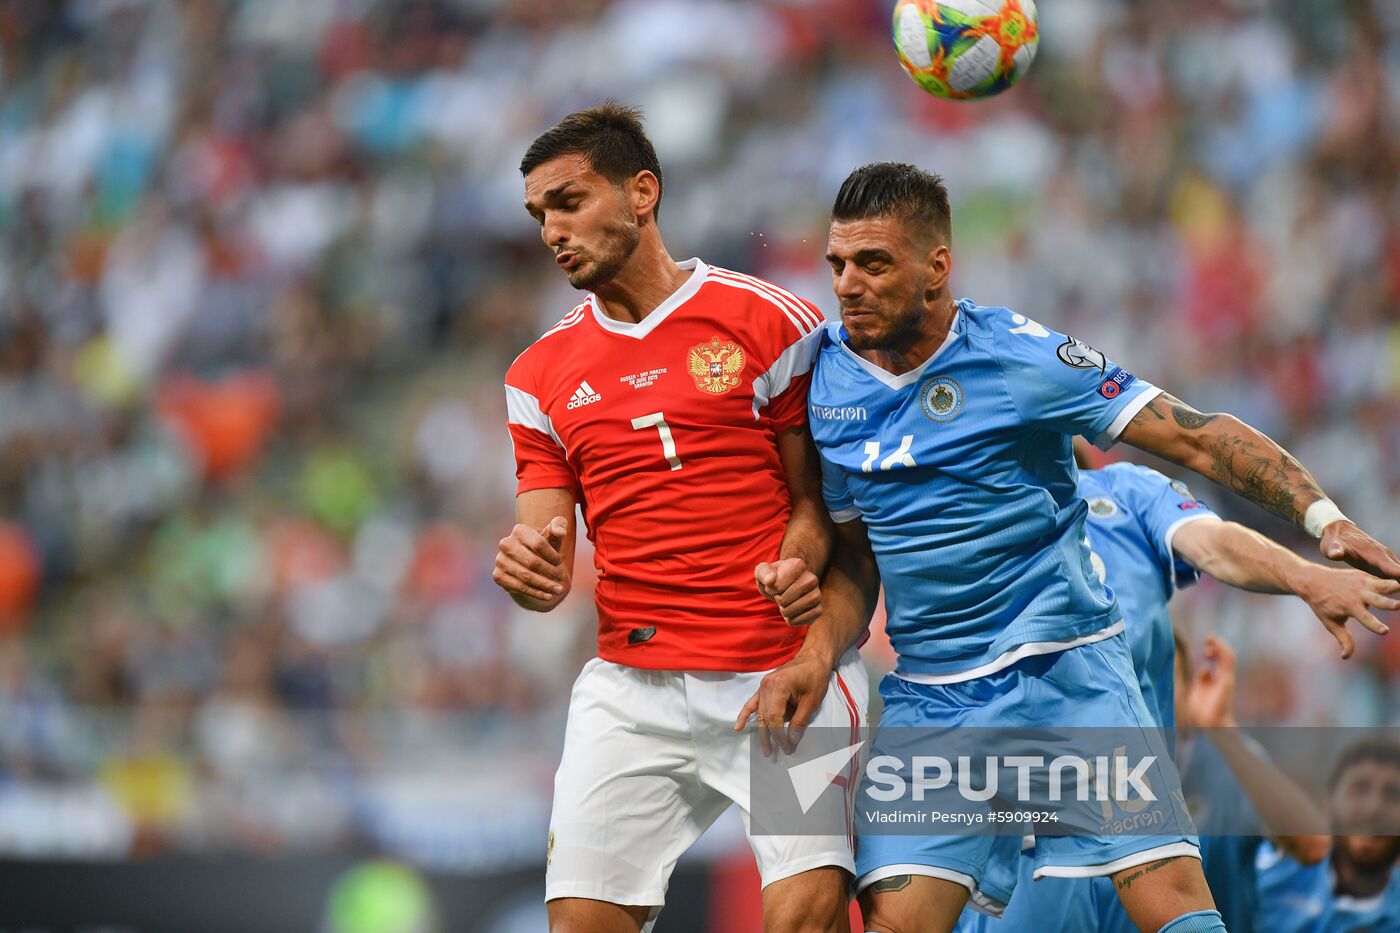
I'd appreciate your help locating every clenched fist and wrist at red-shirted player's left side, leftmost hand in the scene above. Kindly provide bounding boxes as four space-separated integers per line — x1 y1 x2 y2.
491 489 578 612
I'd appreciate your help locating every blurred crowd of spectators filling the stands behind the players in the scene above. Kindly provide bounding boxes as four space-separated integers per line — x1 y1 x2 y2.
0 0 1400 850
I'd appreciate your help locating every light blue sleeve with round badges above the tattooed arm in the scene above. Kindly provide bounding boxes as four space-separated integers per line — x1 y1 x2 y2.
993 315 1162 450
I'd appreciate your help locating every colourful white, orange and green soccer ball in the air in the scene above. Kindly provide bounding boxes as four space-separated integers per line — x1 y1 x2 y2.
895 0 1040 101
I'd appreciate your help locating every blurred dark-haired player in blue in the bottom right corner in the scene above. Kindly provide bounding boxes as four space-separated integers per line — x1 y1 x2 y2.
1254 738 1400 933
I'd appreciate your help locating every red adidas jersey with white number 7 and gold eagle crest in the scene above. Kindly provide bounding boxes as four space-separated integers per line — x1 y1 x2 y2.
505 259 822 671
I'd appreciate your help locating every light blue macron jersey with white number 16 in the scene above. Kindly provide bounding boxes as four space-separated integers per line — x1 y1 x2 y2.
808 300 1158 682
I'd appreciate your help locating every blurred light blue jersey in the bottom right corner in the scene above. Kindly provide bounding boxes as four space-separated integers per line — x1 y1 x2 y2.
1254 842 1400 933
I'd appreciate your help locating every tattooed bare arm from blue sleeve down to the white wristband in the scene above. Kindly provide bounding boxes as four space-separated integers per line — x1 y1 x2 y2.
1123 392 1327 528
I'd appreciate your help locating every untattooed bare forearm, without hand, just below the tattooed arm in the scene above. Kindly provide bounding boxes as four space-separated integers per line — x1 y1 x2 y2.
1173 521 1316 595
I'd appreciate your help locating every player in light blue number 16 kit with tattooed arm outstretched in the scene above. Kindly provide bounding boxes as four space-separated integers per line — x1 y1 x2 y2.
756 164 1400 933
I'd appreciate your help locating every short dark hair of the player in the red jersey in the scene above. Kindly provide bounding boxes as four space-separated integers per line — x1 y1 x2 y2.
521 98 662 218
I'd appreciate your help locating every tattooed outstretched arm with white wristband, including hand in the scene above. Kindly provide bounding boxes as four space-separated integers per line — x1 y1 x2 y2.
1119 392 1400 580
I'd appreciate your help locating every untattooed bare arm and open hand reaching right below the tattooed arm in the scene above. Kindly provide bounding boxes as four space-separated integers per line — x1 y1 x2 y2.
1172 521 1400 658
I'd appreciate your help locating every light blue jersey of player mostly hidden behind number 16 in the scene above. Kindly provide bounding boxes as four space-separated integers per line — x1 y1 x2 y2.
1079 464 1217 728
